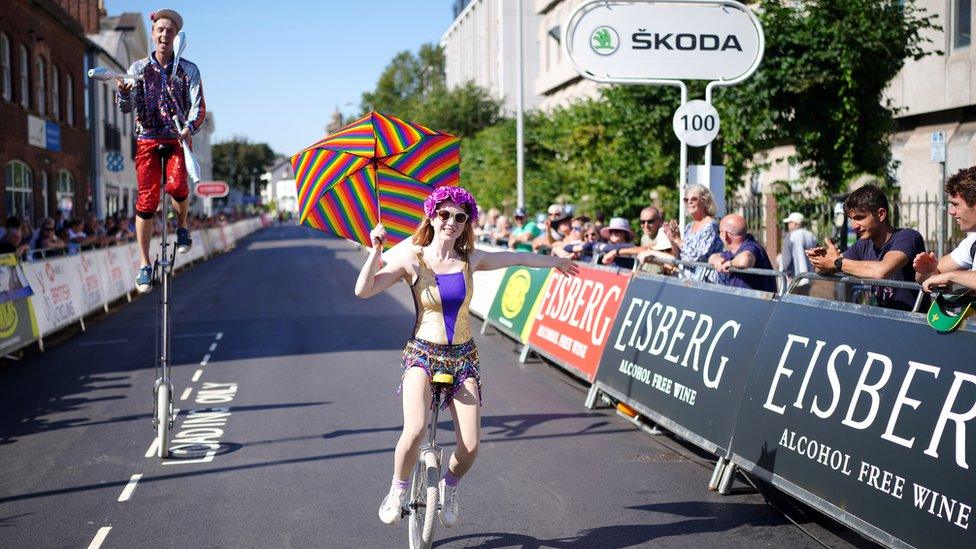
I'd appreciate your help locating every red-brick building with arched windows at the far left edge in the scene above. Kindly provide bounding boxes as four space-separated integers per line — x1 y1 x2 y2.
0 0 99 225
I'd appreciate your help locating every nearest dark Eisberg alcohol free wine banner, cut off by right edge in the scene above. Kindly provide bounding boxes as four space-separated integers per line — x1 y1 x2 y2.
732 296 976 547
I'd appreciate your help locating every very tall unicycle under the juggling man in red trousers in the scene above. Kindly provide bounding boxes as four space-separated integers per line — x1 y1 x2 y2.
152 145 176 458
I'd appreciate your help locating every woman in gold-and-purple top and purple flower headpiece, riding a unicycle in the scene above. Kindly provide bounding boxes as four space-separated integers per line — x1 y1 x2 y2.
355 187 578 527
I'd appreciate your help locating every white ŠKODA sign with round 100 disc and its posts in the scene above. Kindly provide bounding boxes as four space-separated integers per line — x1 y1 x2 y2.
562 0 765 227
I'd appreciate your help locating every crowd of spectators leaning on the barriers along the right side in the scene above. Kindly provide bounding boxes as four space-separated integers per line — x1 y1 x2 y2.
468 166 976 311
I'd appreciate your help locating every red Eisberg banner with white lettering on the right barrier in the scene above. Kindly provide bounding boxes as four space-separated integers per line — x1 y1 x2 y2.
529 266 630 382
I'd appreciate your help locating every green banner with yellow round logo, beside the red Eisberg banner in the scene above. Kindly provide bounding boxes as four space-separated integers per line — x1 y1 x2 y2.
486 267 551 343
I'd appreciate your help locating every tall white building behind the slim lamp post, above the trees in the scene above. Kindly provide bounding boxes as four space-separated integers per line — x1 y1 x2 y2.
440 0 539 116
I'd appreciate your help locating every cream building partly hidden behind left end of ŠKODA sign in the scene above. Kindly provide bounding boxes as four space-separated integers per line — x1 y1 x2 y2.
533 0 606 112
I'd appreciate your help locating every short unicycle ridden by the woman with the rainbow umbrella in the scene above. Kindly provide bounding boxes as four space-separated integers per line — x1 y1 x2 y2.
407 371 454 549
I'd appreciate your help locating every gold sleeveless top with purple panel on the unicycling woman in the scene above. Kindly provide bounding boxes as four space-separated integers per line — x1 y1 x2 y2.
410 251 473 345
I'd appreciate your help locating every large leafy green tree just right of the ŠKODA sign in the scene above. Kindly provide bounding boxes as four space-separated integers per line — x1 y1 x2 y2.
715 0 938 192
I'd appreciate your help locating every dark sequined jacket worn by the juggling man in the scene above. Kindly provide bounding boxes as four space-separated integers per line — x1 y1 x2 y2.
116 52 207 138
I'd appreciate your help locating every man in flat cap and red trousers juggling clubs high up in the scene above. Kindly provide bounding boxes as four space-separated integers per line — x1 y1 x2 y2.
118 9 207 293
